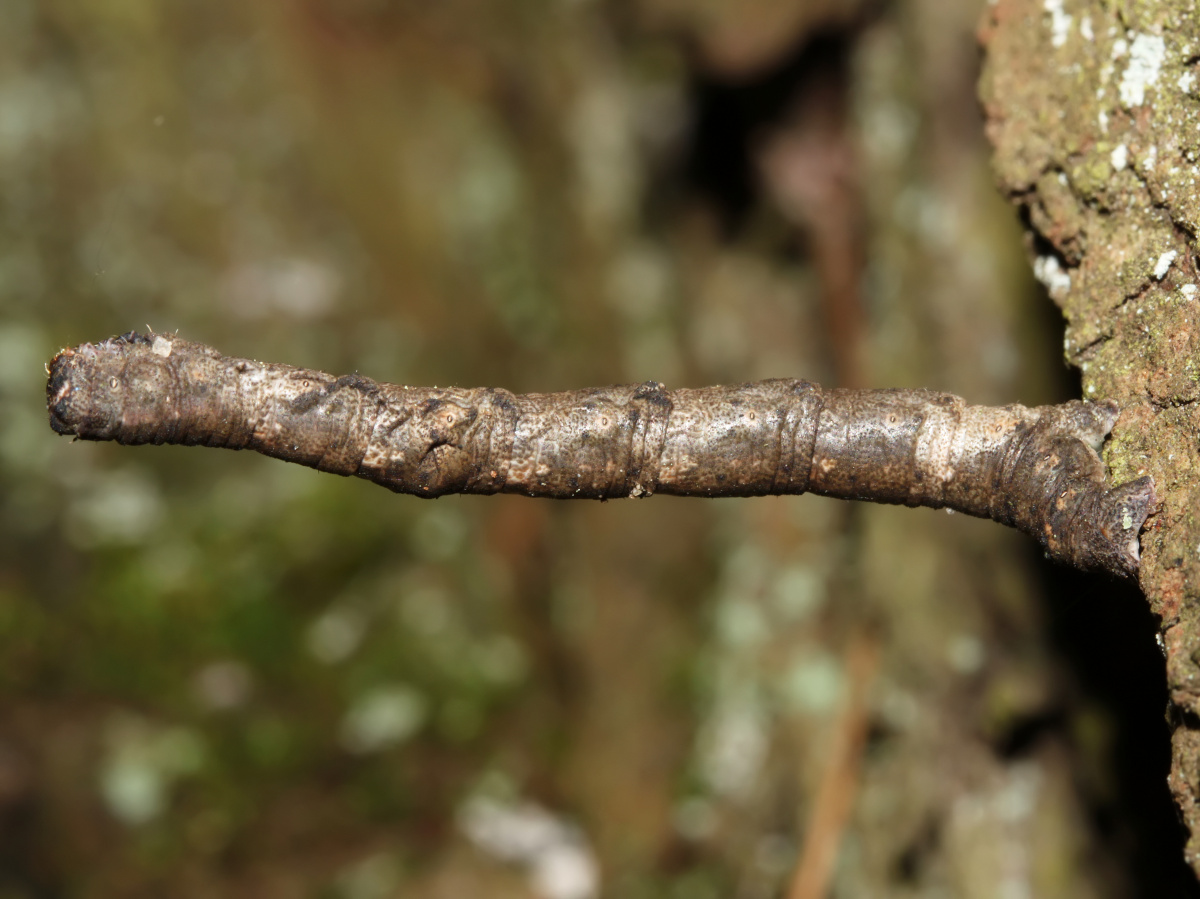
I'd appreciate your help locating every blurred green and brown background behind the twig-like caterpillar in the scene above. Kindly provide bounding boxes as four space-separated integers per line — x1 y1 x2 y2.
0 0 1196 899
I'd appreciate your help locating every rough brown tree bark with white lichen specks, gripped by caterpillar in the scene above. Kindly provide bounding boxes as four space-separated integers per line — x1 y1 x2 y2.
982 0 1200 873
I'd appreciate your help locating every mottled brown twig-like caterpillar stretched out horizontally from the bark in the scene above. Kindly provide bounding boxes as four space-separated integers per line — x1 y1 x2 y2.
47 332 1154 575
